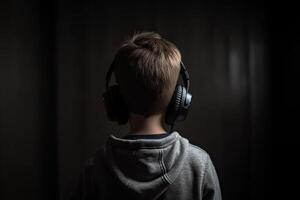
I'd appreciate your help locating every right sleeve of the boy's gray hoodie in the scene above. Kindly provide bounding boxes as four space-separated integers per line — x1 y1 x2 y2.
203 156 222 200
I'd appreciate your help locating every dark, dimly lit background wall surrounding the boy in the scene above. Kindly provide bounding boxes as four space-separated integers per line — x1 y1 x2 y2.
0 0 299 200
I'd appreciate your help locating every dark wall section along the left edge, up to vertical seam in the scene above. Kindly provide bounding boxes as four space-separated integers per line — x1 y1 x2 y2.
0 1 58 199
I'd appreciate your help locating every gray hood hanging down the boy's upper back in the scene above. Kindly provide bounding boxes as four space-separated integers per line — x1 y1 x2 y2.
106 131 189 200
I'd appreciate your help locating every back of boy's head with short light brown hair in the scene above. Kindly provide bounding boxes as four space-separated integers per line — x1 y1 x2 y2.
113 32 181 117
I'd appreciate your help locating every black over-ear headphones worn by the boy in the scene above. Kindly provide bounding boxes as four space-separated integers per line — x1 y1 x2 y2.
102 61 192 130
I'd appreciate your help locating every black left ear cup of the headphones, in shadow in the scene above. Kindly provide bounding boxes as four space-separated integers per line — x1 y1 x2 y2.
103 85 128 125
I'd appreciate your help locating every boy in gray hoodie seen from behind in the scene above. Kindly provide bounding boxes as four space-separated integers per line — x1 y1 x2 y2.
72 32 221 200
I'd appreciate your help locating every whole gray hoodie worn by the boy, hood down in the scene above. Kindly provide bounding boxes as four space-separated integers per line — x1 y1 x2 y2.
71 131 221 200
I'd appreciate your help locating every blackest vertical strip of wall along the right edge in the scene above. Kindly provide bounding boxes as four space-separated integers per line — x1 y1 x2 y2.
267 2 300 199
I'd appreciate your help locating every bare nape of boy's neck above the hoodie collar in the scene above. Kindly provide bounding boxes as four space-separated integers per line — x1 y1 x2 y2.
128 113 167 135
